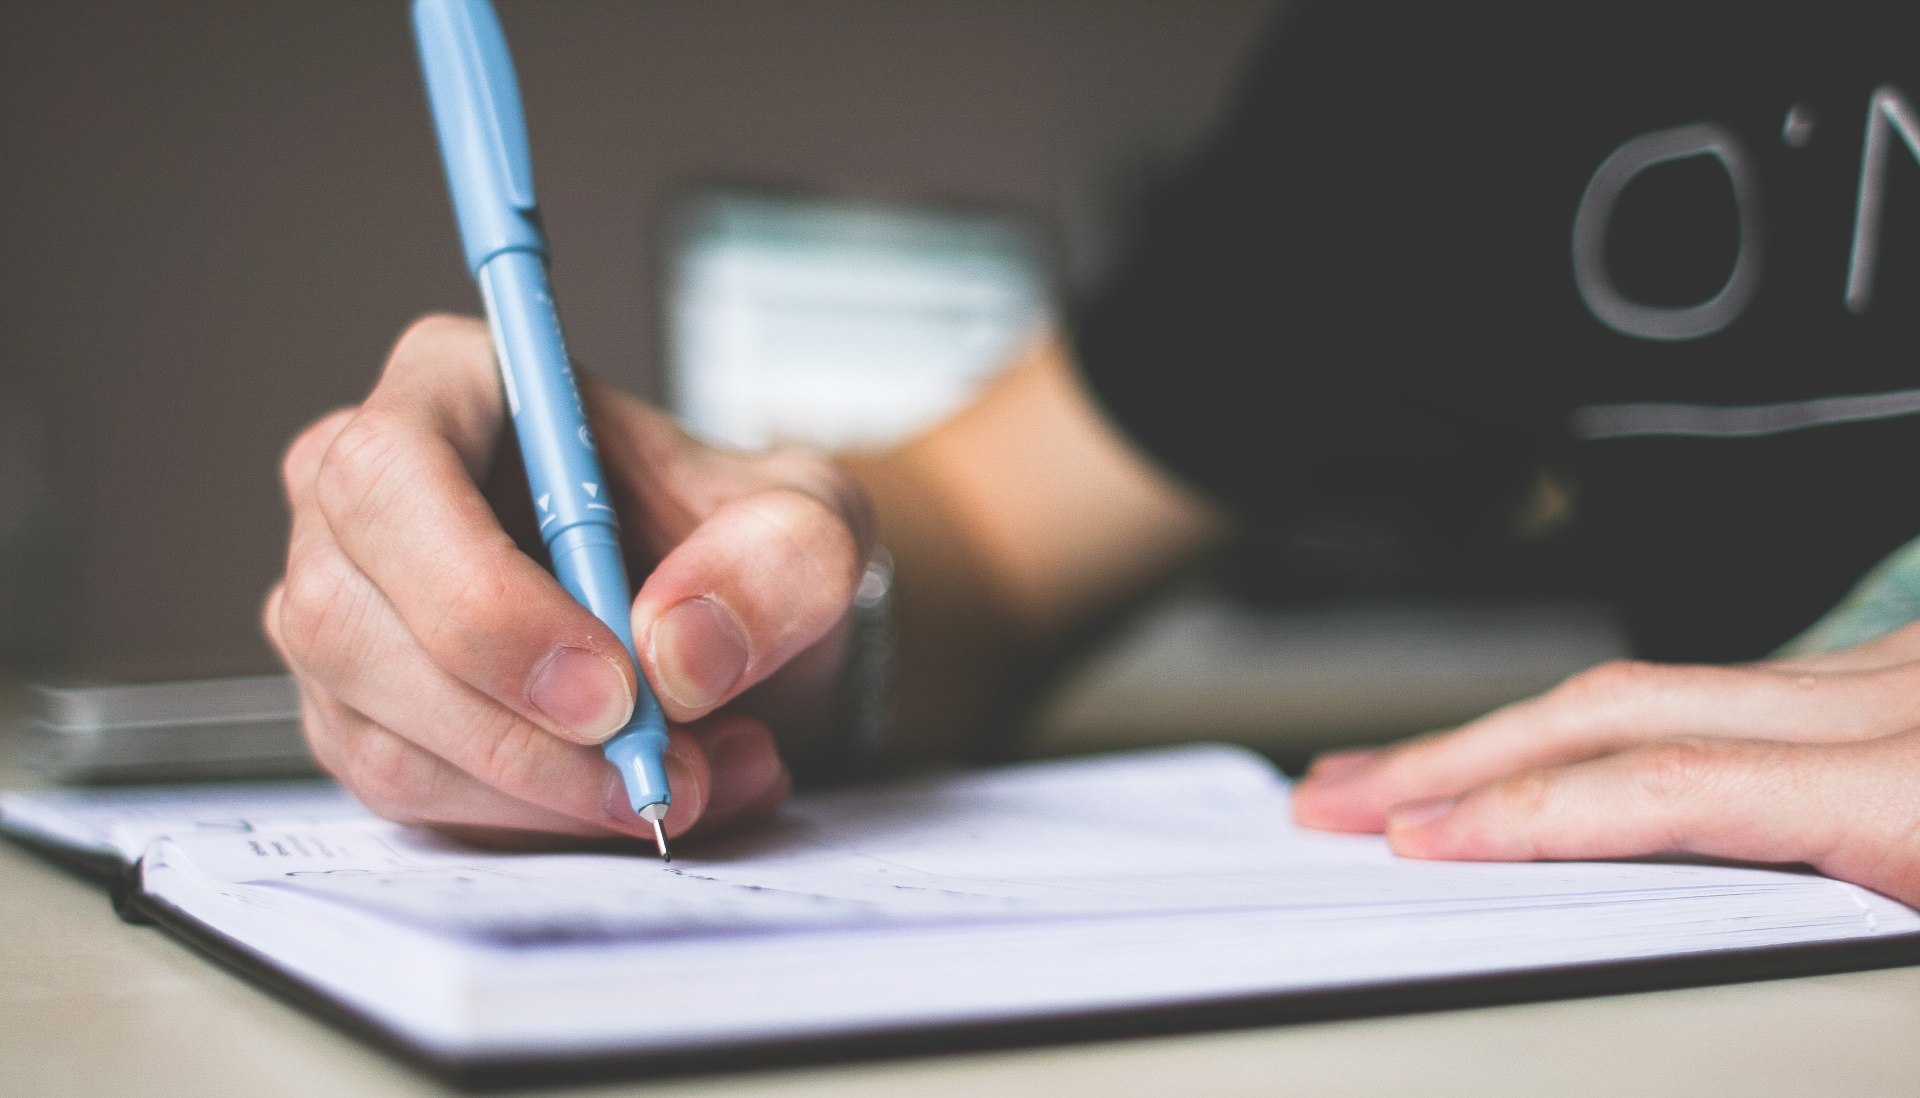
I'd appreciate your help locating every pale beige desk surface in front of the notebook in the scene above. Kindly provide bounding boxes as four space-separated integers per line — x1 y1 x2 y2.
11 706 1920 1098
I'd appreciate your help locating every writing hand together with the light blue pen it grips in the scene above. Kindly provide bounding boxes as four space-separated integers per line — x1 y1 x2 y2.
267 0 872 856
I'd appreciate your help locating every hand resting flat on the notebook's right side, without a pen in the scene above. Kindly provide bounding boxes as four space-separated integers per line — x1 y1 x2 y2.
1294 626 1920 904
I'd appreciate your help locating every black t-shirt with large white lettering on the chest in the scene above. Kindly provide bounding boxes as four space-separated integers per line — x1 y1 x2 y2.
1073 0 1920 660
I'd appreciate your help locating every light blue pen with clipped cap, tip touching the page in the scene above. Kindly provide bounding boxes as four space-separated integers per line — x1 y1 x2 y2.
413 0 672 860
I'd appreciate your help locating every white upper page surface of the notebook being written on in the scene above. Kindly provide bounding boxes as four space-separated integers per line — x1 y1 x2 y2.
153 747 1889 944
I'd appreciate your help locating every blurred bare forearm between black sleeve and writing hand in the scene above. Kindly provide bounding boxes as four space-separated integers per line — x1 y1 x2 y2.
847 342 1223 758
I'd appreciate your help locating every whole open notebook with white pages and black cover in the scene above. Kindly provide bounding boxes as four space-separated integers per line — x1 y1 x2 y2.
0 747 1920 1073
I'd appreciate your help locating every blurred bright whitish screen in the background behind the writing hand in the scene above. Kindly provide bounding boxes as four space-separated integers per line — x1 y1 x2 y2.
666 190 1048 449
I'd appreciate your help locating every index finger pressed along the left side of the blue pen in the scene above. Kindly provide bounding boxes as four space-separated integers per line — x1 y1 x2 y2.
315 317 634 743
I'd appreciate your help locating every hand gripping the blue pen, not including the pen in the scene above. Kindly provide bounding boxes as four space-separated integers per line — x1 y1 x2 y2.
263 317 872 839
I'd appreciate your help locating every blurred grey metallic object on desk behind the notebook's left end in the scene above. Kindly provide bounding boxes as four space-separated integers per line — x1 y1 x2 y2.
27 676 315 785
